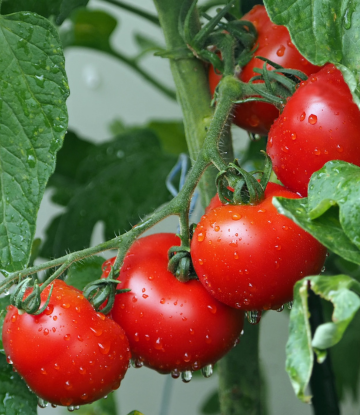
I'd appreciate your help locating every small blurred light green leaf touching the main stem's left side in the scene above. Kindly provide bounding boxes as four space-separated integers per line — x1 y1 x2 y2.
147 121 188 155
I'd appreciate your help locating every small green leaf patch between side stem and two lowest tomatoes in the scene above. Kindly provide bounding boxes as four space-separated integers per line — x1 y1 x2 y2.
66 256 105 290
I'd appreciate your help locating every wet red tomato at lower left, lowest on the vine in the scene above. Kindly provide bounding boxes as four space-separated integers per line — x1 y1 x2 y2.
2 280 130 406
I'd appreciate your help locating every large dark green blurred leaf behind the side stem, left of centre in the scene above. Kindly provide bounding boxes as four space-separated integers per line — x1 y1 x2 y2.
41 129 176 257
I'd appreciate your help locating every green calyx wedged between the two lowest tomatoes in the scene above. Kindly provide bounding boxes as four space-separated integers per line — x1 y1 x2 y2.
83 267 131 314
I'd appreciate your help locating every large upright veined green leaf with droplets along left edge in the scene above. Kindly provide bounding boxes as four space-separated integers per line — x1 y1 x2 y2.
0 12 69 271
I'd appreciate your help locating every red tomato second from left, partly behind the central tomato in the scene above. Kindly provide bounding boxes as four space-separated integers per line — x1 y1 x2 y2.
103 233 244 376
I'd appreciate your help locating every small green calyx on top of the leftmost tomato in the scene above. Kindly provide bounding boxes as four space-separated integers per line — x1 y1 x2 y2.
10 277 54 315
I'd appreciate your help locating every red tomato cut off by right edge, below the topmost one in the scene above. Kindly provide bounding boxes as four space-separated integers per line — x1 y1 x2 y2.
267 64 360 196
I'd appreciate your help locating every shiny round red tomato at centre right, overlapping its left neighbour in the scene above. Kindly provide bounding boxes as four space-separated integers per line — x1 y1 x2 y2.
191 183 326 310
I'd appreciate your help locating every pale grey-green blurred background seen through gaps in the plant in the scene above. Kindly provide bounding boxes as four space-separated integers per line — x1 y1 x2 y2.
36 0 359 415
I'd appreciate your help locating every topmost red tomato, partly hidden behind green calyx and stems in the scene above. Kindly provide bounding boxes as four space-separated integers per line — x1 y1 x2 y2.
209 5 320 135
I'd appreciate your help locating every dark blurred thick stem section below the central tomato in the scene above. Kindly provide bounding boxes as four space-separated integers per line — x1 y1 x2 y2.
219 322 265 415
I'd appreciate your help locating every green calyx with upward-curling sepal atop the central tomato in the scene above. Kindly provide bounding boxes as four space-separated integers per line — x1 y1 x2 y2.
216 152 272 205
